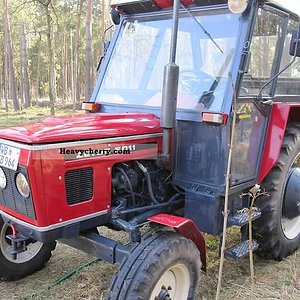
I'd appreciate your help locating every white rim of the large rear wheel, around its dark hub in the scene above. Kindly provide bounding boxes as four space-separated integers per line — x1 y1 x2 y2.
281 153 300 240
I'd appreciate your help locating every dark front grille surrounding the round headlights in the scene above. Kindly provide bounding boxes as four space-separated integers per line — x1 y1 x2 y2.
0 167 36 219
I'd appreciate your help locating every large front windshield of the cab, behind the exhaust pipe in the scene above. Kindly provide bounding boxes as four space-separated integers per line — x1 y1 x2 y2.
93 1 241 117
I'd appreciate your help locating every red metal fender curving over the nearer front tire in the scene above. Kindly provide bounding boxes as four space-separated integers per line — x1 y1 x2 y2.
148 214 206 272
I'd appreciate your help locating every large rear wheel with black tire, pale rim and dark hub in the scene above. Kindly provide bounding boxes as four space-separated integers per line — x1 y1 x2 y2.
253 124 300 260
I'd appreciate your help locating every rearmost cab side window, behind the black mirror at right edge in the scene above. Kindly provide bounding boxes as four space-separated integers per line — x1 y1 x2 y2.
276 20 300 95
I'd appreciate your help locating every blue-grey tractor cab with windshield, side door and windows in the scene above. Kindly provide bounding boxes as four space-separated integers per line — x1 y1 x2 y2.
91 0 300 233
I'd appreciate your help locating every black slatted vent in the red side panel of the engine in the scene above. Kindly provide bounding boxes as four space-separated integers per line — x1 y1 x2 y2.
65 168 93 205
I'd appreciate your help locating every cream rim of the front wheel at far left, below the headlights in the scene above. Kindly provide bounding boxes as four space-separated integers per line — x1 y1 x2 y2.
0 224 43 264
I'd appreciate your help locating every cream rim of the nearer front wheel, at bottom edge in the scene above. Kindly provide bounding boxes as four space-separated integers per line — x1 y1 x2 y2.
150 264 191 300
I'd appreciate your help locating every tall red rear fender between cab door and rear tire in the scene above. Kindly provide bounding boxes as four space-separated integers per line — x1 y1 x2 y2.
258 104 291 183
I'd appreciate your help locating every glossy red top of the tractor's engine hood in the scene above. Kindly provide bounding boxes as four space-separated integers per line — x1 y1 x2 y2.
0 113 161 144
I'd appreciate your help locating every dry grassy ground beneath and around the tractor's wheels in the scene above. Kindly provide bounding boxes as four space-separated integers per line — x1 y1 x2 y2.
0 229 300 300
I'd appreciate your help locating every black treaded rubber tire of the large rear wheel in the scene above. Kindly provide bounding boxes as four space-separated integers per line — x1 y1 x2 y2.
253 124 300 260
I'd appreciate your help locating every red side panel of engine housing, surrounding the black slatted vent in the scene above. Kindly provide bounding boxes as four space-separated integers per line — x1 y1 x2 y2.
0 138 161 227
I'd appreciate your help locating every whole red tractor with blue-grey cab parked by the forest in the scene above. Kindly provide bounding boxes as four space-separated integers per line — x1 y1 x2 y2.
0 0 300 300
